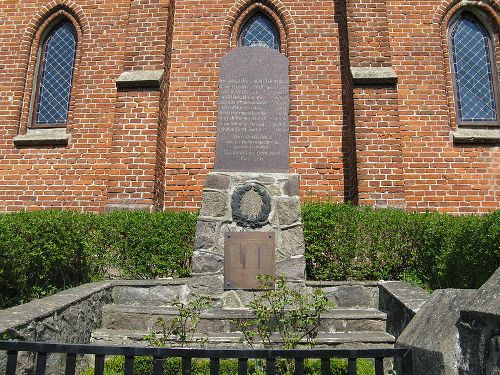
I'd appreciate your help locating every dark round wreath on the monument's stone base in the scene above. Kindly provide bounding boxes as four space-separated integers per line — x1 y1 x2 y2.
231 184 271 228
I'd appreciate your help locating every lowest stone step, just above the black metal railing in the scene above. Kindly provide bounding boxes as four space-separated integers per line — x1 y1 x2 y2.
91 329 395 349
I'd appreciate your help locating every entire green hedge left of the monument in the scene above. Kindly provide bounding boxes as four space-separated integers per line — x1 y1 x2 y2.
0 211 196 307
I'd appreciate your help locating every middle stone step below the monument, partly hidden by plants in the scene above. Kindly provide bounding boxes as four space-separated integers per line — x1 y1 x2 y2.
102 304 387 333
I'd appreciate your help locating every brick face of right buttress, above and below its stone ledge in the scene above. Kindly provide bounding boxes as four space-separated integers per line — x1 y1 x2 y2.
347 0 405 208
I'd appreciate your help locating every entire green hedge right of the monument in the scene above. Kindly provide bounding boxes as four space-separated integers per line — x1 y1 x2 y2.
302 203 500 289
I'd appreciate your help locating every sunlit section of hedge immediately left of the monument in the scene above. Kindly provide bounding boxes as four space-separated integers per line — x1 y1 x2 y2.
95 212 196 279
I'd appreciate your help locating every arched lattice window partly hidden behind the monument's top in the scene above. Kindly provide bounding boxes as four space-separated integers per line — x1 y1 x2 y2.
239 13 280 50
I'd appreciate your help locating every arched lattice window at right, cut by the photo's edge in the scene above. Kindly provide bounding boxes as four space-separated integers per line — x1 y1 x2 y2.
449 12 498 124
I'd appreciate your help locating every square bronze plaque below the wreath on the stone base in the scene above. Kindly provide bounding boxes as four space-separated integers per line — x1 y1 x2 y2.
224 232 276 290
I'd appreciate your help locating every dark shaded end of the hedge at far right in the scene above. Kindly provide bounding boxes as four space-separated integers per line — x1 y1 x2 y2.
413 211 500 289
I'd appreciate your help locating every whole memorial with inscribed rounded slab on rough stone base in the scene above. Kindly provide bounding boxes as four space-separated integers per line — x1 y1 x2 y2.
193 47 305 289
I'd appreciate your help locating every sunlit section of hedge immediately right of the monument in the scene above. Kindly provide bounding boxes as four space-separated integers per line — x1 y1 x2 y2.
302 203 412 280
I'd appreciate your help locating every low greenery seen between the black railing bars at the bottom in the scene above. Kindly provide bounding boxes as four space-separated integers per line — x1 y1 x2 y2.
80 356 375 375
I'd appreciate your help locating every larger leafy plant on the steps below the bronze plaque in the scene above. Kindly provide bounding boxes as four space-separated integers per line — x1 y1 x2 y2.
237 275 332 374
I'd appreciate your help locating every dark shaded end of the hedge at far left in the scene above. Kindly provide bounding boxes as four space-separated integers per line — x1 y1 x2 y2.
0 211 92 306
